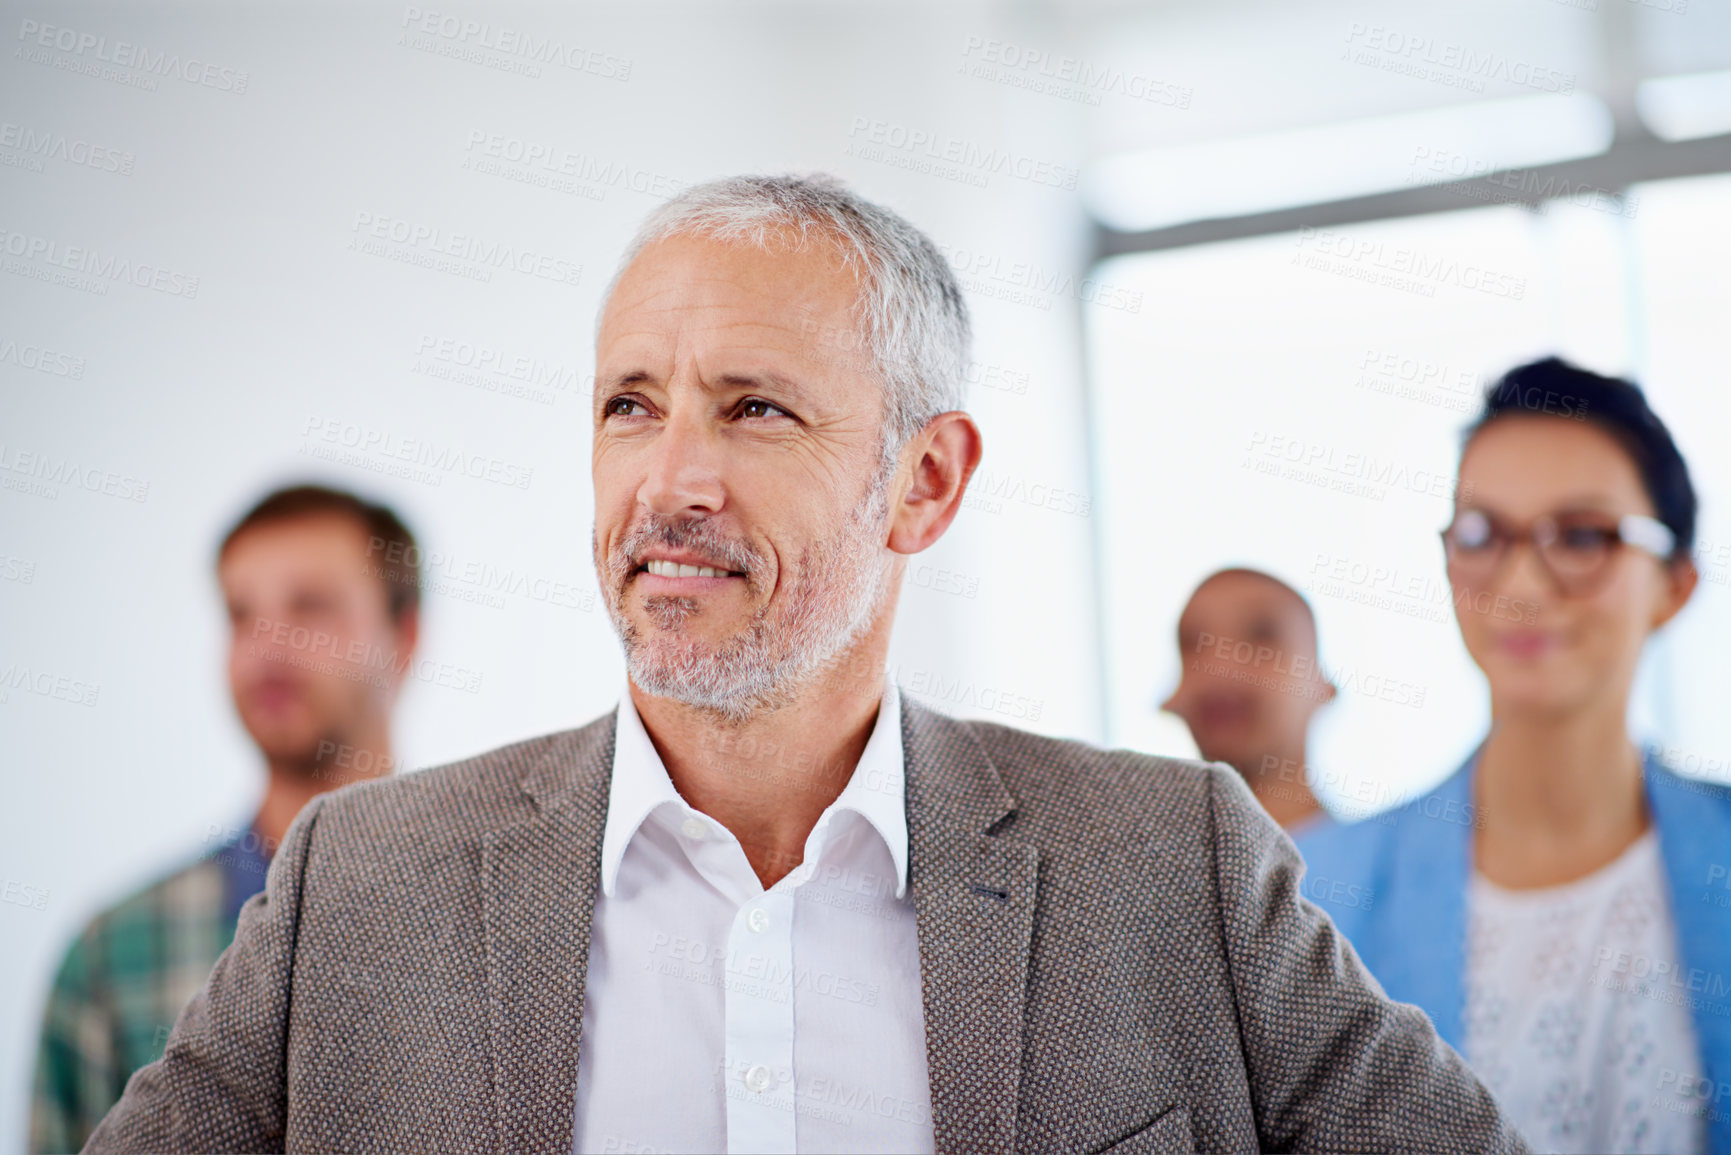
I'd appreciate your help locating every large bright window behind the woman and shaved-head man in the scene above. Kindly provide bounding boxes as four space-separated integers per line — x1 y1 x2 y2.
1087 177 1731 810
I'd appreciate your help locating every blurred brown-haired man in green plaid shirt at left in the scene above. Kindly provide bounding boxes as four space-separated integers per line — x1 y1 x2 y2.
31 485 421 1152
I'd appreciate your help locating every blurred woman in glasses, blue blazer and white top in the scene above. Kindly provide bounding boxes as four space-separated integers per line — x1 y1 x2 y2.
1298 358 1731 1155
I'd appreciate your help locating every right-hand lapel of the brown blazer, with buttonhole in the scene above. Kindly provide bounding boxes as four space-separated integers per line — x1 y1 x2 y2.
902 694 1039 1152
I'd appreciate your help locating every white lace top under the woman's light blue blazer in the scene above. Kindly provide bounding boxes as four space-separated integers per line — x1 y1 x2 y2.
1464 829 1707 1155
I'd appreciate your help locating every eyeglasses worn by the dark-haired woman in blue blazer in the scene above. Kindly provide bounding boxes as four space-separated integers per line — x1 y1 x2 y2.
1442 509 1677 594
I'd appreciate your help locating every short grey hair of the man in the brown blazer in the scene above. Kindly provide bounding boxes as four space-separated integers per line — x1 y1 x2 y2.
595 173 973 454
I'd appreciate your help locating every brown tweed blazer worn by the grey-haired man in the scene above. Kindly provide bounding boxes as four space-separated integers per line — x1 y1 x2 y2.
85 701 1523 1153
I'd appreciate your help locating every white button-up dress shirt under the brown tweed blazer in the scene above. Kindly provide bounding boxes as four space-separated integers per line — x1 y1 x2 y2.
571 686 933 1155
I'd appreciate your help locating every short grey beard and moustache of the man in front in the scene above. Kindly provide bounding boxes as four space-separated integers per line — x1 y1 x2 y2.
595 476 890 724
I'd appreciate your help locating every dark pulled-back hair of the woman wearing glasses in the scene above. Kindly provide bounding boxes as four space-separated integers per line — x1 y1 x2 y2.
1461 357 1698 559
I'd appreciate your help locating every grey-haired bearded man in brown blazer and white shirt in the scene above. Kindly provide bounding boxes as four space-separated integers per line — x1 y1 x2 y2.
92 178 1516 1152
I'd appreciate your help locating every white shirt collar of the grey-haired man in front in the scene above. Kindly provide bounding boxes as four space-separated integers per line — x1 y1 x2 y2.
601 684 907 899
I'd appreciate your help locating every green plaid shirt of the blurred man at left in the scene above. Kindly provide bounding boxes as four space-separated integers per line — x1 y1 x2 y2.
29 838 267 1152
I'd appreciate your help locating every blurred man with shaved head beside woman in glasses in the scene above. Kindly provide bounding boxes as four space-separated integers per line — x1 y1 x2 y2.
1162 568 1335 831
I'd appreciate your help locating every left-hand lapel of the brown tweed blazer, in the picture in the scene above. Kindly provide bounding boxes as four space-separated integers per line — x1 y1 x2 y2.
481 715 615 1152
